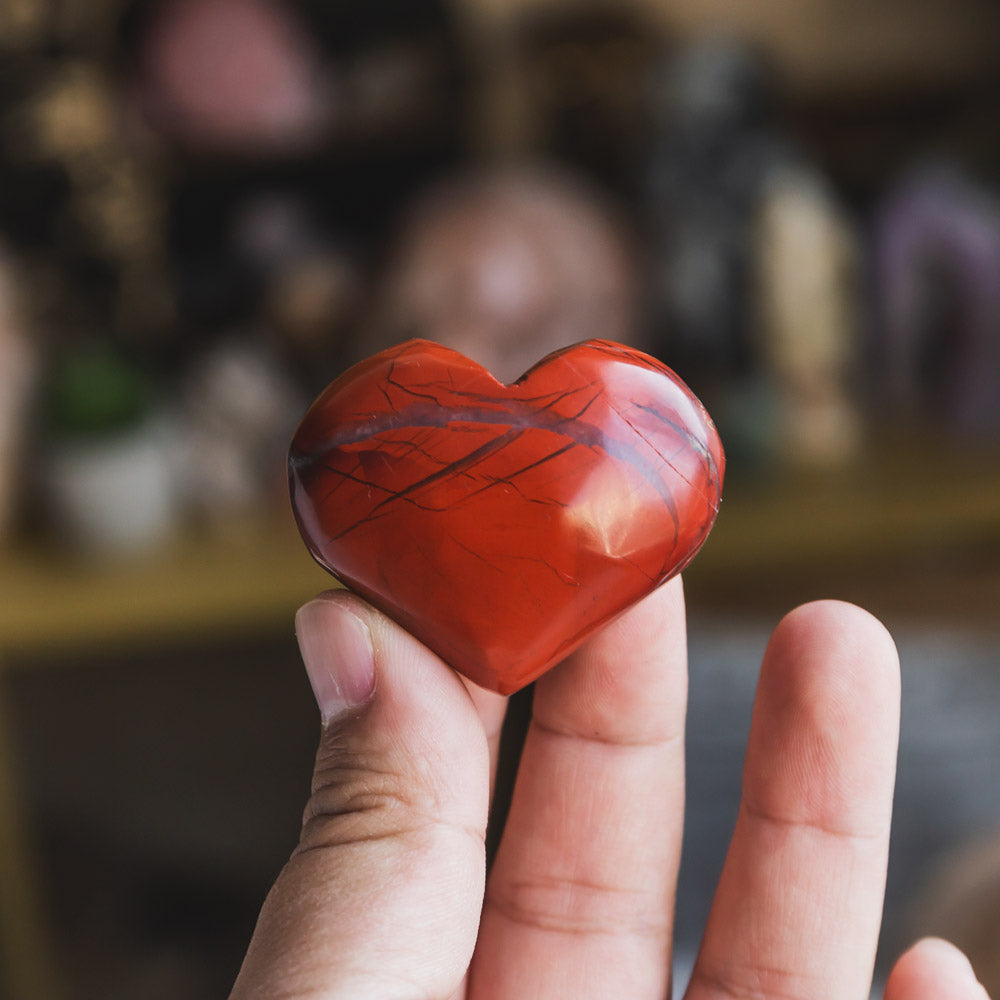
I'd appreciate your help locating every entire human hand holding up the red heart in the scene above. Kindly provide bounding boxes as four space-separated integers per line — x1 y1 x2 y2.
231 579 986 1000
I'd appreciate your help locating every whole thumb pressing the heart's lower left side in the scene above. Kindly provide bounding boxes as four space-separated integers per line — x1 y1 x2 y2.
231 591 489 1000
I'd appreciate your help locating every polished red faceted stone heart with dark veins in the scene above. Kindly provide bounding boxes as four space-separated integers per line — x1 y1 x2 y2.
288 340 724 693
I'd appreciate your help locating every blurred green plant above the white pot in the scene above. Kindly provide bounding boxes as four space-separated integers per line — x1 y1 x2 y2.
43 344 155 438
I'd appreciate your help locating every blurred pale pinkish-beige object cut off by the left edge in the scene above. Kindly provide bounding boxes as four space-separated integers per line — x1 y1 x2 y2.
0 254 37 538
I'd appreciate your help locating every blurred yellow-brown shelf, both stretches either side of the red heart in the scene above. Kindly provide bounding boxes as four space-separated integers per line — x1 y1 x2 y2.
0 449 1000 656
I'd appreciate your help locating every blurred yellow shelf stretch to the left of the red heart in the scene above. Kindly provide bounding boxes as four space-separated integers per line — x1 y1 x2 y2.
0 515 333 655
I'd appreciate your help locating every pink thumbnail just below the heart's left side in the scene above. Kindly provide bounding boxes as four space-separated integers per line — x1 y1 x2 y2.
295 597 375 725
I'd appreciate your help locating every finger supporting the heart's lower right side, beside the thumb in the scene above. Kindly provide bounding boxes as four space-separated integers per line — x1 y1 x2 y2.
470 579 687 1000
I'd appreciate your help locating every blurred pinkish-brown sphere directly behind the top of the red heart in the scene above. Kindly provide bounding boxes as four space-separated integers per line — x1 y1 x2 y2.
362 167 641 380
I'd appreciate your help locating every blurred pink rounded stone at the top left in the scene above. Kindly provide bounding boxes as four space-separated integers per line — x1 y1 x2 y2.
141 0 329 152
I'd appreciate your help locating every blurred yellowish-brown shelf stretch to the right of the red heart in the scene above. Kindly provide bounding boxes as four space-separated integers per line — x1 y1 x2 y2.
685 439 1000 627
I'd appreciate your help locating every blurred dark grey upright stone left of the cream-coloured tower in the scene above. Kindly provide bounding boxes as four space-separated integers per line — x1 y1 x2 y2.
645 40 788 378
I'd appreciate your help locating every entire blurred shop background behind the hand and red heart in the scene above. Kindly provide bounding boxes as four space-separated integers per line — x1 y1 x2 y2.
0 0 1000 1000
